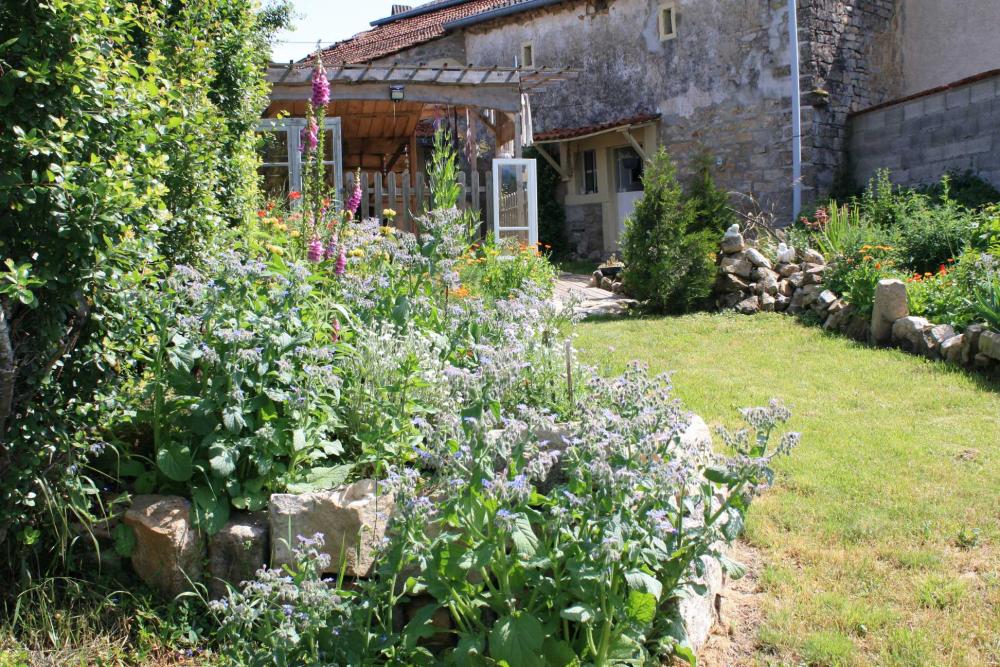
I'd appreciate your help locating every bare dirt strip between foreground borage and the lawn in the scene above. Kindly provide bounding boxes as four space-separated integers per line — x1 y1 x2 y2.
698 541 764 667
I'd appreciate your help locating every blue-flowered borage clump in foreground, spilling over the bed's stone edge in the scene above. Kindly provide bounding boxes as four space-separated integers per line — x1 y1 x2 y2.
216 365 798 667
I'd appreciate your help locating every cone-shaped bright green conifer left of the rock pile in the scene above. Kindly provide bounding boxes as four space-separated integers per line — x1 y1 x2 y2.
622 149 718 312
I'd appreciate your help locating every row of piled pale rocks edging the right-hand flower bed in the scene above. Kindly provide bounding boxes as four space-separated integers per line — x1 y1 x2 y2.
715 225 1000 370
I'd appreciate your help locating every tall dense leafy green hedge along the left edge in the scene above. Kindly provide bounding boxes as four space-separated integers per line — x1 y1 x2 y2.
0 0 284 580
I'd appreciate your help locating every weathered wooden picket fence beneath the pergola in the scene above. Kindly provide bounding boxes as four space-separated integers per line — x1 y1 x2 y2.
344 171 494 231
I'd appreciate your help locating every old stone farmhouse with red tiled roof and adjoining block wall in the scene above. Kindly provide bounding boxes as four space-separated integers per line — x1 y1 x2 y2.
272 0 1000 257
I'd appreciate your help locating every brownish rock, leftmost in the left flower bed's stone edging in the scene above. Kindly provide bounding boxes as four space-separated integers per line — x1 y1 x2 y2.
125 496 205 597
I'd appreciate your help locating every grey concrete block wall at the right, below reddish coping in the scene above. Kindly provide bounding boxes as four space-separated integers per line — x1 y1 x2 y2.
850 74 1000 192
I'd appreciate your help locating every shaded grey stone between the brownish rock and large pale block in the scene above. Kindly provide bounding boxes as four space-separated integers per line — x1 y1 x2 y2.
208 512 270 599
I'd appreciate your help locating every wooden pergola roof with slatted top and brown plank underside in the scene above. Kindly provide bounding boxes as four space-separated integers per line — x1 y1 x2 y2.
264 63 579 176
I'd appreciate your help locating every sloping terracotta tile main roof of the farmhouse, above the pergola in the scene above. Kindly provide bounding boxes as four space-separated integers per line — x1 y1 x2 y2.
323 0 526 65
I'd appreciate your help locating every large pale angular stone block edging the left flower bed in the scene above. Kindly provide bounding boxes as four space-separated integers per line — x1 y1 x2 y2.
270 479 393 577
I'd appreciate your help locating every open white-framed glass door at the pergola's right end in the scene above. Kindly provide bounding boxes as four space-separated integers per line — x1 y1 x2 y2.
493 158 538 246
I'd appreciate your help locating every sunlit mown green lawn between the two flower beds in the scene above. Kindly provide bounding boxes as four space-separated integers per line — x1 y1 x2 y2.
577 315 1000 666
